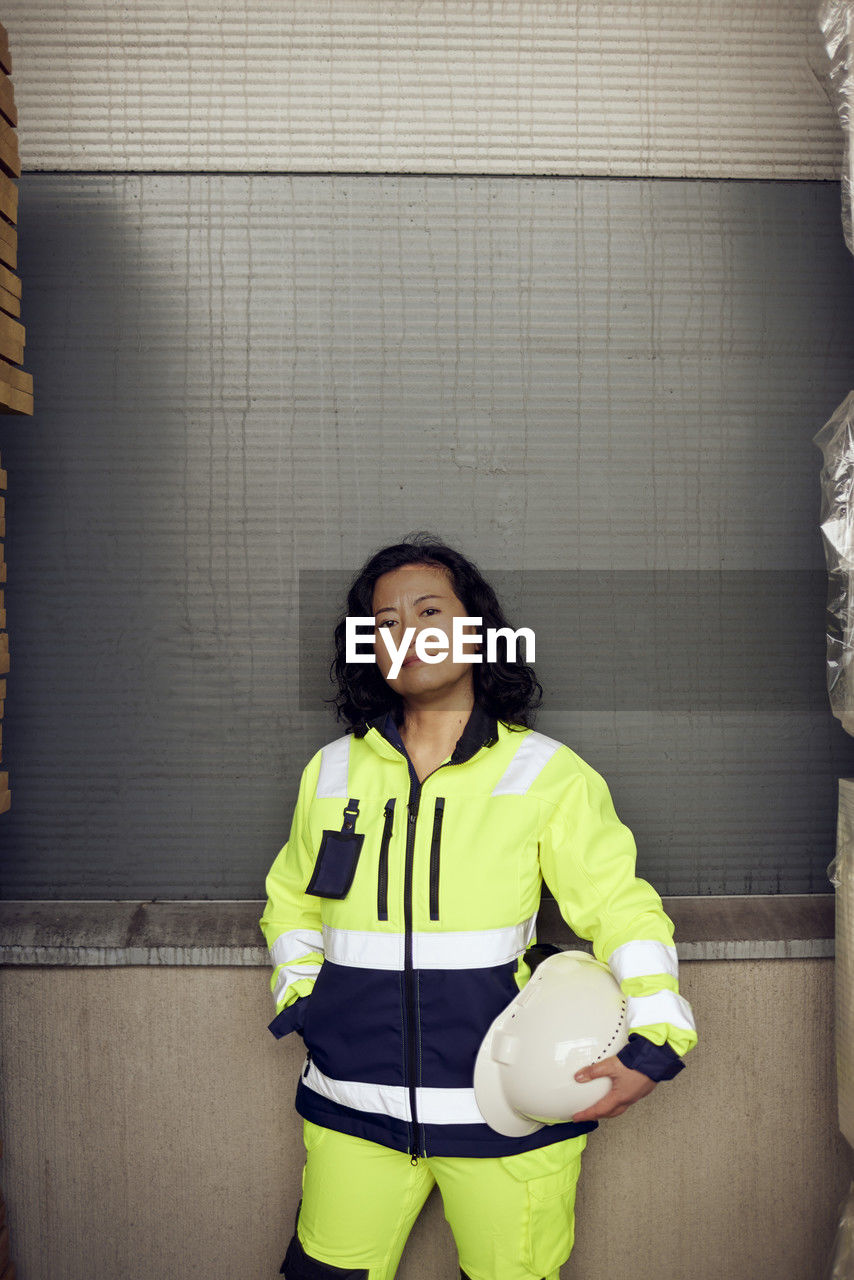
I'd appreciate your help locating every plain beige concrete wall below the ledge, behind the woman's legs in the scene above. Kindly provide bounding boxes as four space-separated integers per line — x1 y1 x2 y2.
0 959 851 1280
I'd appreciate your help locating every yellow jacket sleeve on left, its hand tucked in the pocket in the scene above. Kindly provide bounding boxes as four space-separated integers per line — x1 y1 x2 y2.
260 753 323 1038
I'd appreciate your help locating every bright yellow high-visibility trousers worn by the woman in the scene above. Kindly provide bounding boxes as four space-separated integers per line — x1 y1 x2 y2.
290 1120 586 1280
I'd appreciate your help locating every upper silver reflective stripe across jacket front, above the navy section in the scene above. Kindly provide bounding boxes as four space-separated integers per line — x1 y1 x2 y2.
323 915 536 973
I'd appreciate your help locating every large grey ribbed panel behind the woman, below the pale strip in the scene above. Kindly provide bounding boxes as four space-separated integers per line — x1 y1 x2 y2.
0 175 854 899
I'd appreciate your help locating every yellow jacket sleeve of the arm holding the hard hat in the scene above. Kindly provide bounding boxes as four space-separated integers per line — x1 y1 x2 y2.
540 748 697 1079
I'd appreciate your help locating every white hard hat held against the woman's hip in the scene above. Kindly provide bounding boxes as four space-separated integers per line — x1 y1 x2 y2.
475 951 629 1138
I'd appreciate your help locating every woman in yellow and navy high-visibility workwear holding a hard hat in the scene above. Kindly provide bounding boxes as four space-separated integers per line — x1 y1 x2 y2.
261 535 697 1280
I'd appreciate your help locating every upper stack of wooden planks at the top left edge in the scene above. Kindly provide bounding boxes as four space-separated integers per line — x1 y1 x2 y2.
0 24 32 413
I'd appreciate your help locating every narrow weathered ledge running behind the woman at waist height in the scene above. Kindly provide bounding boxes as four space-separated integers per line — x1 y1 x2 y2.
0 893 835 968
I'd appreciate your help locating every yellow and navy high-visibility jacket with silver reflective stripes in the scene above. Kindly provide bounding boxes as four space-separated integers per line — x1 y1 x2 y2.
260 707 697 1156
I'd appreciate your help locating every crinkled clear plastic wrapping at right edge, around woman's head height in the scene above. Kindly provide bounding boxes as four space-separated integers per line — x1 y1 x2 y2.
813 392 854 733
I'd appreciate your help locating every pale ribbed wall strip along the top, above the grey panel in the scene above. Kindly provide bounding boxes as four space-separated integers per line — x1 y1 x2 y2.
4 0 841 178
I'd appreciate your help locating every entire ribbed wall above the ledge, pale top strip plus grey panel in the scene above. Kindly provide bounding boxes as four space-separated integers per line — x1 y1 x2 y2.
0 0 854 897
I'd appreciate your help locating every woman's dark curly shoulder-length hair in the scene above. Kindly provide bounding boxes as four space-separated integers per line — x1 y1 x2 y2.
329 532 543 728
